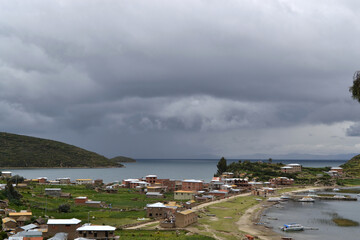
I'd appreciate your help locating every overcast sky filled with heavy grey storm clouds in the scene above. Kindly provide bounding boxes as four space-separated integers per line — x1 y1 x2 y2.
0 0 360 158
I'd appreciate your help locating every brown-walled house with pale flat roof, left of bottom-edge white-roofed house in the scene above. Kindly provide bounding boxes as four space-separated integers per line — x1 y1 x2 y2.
47 218 81 240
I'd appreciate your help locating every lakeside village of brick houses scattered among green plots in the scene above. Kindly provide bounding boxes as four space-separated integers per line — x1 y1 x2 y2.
0 164 343 240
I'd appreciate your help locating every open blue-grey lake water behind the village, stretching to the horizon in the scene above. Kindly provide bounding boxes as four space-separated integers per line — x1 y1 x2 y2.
2 159 346 182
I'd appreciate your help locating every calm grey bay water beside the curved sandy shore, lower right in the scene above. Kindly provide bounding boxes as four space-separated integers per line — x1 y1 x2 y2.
261 188 360 240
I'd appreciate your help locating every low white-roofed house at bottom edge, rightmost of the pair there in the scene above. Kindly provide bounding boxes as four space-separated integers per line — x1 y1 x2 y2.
76 224 117 240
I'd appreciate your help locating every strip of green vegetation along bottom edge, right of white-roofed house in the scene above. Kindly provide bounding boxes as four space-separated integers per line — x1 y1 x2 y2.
115 230 214 240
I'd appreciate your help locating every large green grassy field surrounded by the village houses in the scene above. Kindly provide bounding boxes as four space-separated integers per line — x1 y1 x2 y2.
10 185 173 227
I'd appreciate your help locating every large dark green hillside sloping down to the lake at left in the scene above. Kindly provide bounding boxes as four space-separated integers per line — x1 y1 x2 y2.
0 132 122 168
